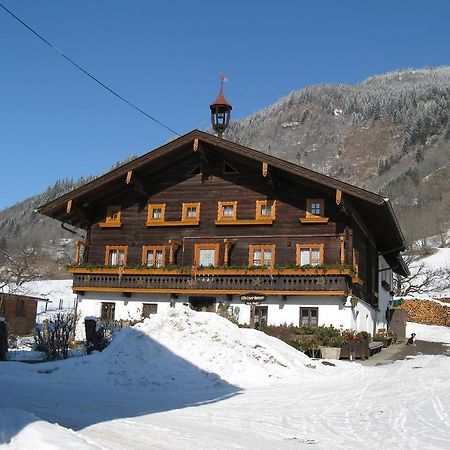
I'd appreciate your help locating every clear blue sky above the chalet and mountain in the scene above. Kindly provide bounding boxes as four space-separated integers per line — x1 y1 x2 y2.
0 0 450 209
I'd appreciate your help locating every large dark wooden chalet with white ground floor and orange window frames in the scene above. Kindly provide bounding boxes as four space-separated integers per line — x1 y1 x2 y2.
39 130 407 332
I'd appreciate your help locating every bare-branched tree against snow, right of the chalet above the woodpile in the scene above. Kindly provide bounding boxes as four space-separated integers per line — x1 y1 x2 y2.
396 255 450 297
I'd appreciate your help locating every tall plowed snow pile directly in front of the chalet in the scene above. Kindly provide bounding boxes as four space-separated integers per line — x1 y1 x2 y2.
97 307 312 390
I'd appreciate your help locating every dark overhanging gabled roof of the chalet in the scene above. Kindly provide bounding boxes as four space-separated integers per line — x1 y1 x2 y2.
38 130 406 274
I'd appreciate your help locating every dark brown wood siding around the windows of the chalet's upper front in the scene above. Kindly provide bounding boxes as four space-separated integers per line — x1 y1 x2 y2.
87 160 351 266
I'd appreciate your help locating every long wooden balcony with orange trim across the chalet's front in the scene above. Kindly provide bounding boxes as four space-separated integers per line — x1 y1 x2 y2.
69 267 355 295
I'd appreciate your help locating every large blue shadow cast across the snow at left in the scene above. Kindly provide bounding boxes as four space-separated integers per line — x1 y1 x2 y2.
0 328 242 444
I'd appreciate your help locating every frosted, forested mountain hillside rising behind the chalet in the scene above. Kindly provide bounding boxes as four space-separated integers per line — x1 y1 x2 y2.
0 67 450 264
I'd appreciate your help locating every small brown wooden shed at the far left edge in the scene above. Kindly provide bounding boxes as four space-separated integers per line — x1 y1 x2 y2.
0 293 42 335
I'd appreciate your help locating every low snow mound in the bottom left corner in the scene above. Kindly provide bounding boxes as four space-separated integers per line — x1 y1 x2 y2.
0 408 103 450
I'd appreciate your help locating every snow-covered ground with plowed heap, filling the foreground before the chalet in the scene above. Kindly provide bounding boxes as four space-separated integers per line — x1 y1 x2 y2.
0 309 450 450
